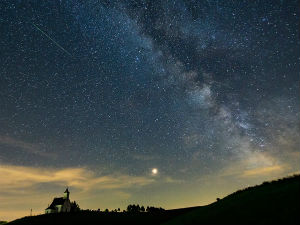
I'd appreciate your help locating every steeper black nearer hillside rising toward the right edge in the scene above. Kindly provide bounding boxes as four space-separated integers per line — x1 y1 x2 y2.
165 175 300 225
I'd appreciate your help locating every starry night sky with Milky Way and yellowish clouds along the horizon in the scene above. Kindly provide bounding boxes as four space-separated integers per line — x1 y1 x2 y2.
0 0 300 220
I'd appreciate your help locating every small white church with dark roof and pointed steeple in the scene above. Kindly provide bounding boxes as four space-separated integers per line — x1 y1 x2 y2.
45 188 72 214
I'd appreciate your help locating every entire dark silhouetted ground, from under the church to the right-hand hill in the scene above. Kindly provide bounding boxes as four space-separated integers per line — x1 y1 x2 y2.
9 175 300 225
